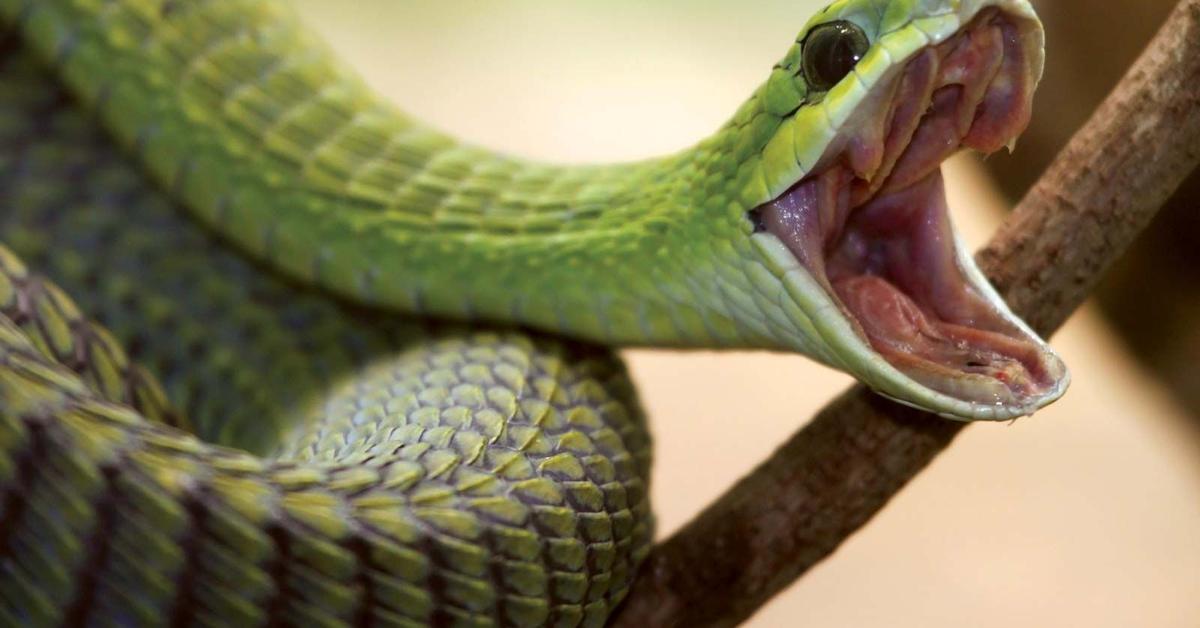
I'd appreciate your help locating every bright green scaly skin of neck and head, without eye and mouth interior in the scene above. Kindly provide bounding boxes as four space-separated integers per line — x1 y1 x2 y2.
0 0 1067 420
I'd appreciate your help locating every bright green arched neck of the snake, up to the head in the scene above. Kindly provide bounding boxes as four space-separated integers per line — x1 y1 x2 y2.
7 0 796 346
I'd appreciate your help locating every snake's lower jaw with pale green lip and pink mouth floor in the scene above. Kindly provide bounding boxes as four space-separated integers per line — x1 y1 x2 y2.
754 173 1069 420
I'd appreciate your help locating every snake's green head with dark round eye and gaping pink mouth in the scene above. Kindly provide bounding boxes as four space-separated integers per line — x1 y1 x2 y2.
739 0 1069 420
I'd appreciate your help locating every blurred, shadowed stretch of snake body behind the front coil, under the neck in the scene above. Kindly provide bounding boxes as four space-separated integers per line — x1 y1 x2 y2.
0 48 410 450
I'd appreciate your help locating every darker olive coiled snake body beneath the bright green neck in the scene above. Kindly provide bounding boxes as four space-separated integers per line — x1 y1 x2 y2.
0 41 652 626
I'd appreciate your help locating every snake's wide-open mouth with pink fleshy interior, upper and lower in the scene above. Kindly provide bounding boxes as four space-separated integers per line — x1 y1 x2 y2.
754 8 1066 414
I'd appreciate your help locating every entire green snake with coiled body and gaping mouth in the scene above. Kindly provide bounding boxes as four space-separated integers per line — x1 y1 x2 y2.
0 0 1068 627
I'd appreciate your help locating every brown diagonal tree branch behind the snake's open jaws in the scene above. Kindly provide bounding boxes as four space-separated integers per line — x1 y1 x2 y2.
614 0 1200 627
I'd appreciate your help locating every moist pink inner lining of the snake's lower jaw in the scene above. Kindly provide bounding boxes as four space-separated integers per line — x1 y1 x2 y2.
822 171 1061 407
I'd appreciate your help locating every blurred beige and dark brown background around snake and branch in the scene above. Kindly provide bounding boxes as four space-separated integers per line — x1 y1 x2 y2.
296 0 1200 627
